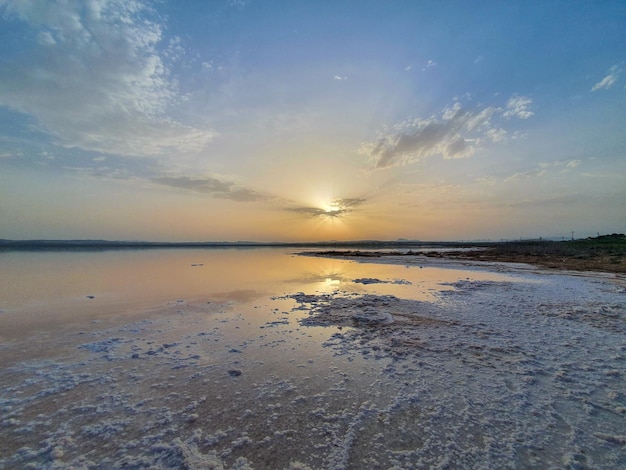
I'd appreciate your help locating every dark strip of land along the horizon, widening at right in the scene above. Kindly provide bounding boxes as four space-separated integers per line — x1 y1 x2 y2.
0 239 626 273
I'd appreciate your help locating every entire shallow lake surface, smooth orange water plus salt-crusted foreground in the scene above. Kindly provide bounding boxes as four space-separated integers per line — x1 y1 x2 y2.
0 249 626 468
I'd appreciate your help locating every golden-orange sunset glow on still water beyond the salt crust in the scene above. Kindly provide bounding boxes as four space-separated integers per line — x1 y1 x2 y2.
0 248 506 315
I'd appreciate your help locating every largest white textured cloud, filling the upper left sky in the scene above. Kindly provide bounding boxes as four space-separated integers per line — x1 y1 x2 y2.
0 0 216 156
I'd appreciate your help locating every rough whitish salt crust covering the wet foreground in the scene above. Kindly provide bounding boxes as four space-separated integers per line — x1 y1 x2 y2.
0 258 626 469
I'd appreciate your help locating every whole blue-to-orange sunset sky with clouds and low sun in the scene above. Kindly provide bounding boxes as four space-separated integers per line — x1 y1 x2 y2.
0 0 626 241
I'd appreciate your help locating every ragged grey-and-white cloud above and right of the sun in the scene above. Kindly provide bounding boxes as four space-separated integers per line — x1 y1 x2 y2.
360 96 533 168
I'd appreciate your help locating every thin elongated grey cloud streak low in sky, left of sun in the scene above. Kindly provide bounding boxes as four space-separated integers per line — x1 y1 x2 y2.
152 176 272 202
